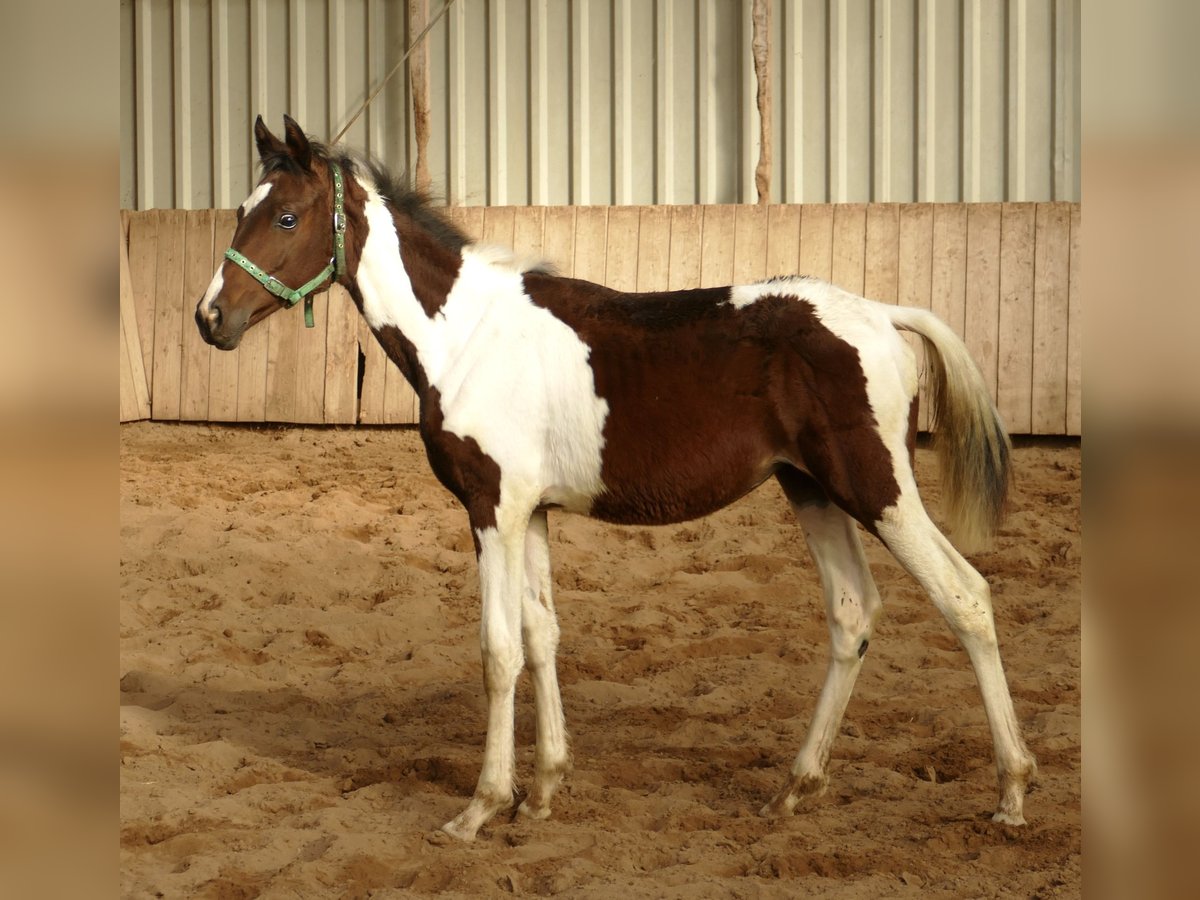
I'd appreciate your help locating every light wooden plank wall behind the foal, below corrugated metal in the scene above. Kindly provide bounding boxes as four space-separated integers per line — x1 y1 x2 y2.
121 203 1082 434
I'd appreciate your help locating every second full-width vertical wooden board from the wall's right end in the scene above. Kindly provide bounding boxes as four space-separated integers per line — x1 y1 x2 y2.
996 203 1034 434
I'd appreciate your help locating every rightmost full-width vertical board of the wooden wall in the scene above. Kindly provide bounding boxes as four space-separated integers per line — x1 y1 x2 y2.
1032 203 1070 434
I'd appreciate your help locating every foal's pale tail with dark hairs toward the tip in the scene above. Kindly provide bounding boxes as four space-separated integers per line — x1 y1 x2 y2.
886 306 1012 552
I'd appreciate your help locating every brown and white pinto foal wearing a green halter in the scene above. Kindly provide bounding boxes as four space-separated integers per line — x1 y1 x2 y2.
196 118 1034 840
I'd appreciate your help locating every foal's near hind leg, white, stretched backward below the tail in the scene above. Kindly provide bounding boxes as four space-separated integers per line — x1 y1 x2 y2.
878 481 1037 824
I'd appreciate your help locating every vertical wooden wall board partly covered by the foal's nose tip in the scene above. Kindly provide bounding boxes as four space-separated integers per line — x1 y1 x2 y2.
179 209 221 421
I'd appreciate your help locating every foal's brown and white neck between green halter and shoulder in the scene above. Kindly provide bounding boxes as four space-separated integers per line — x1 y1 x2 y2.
352 185 462 392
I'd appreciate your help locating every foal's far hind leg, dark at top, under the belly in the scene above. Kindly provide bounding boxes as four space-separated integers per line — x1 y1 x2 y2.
762 470 882 816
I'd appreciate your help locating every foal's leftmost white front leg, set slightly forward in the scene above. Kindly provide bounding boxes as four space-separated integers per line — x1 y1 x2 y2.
442 515 529 841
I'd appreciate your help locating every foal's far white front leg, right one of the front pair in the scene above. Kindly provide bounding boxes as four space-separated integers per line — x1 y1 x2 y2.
517 511 570 818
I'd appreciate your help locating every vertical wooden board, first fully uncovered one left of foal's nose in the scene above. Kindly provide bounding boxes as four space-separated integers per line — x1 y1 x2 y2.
151 210 186 419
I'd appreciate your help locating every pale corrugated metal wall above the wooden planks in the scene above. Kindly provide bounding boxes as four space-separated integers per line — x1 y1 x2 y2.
121 0 1080 209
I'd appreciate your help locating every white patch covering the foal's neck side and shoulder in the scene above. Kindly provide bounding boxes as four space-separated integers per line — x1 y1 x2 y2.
358 177 608 513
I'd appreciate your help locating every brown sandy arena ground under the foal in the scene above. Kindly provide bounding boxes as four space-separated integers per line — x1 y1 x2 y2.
120 422 1081 898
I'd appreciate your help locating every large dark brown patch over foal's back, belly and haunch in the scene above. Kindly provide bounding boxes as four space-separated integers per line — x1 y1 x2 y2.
524 275 900 528
